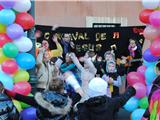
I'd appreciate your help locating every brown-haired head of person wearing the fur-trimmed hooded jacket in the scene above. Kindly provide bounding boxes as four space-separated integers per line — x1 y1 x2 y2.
49 77 64 93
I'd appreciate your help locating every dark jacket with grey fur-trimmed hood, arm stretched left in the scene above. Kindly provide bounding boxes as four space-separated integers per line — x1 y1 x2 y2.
14 91 72 120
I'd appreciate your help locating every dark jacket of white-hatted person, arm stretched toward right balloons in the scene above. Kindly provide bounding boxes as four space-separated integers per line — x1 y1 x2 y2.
77 87 136 120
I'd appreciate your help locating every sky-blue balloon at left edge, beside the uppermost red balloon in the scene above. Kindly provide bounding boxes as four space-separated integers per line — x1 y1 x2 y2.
0 9 16 25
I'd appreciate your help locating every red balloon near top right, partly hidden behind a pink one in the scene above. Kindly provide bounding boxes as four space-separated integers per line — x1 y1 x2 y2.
139 9 154 24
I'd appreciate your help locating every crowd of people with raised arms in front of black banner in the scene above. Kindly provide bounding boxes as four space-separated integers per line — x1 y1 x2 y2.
0 35 156 120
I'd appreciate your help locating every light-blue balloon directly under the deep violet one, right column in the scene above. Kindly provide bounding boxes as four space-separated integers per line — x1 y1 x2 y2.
145 66 156 85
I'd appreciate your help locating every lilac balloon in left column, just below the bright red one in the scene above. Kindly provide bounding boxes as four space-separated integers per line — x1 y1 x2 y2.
7 24 24 39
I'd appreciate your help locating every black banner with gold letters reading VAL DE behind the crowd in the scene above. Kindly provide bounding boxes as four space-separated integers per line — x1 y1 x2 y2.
36 25 145 57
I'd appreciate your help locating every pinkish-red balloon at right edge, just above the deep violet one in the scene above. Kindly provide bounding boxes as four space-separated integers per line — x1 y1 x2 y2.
150 40 160 56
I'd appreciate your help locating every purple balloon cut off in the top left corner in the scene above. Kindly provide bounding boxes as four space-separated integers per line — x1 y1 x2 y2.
0 0 16 9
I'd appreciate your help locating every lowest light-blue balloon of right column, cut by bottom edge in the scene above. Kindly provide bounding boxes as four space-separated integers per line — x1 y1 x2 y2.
131 109 145 120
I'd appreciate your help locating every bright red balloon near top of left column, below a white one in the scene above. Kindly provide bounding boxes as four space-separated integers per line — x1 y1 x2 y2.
16 12 35 30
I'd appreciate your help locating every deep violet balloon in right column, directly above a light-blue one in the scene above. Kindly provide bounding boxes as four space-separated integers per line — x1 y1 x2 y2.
143 49 159 62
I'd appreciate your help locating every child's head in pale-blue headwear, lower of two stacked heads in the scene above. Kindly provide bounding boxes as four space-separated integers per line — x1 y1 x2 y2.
106 61 116 73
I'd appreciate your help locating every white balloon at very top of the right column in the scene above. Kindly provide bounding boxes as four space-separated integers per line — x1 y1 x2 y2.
142 0 160 9
